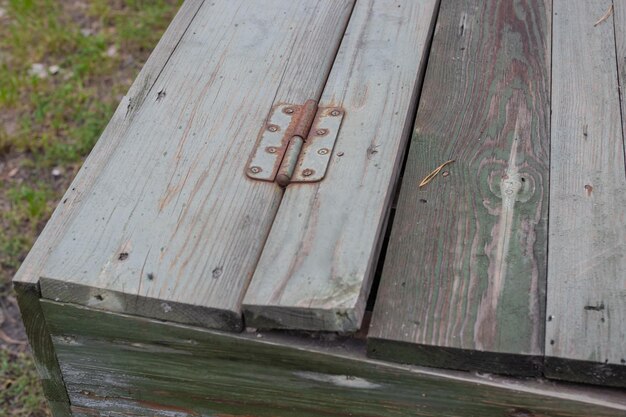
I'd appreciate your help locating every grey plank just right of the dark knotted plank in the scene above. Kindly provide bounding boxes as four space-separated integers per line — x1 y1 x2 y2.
545 0 626 387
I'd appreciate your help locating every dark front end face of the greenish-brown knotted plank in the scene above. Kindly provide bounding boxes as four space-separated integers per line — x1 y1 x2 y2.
367 337 543 377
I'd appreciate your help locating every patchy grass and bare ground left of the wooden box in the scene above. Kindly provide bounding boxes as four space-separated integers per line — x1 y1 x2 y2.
0 0 181 417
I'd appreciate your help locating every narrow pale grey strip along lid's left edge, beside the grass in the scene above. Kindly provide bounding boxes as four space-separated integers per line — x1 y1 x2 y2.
13 0 204 284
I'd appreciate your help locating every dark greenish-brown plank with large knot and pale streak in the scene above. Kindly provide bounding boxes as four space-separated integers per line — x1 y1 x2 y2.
369 0 551 375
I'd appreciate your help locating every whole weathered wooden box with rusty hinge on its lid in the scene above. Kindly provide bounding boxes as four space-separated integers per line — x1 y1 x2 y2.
14 0 626 417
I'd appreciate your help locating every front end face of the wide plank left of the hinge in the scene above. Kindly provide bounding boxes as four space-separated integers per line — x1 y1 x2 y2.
40 277 243 332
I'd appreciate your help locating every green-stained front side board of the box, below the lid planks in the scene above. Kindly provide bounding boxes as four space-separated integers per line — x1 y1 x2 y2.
42 300 626 417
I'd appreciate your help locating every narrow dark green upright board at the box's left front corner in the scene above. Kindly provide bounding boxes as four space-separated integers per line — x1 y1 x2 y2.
14 283 70 417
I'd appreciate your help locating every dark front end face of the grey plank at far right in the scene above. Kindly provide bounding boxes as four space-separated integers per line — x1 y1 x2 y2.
544 356 626 388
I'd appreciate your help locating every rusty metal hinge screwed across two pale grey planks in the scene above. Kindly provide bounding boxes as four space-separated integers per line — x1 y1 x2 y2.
246 100 344 187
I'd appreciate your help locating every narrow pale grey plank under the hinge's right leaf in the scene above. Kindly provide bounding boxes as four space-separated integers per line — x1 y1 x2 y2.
239 0 438 331
